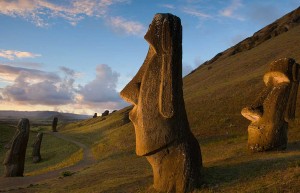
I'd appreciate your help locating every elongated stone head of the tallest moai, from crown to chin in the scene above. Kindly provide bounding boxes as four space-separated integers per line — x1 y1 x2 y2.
120 14 188 156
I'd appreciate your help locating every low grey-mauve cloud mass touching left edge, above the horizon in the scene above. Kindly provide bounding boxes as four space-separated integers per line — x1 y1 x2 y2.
0 65 74 105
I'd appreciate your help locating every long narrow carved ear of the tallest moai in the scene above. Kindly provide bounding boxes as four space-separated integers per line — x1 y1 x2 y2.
159 20 174 118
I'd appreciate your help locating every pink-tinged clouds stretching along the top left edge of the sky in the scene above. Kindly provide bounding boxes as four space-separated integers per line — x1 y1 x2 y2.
0 0 128 27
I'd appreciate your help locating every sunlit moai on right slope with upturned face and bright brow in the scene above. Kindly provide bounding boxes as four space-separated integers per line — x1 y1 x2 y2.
241 58 300 152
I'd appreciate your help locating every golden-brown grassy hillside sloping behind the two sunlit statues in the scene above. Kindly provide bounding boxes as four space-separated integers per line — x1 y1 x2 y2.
1 6 300 193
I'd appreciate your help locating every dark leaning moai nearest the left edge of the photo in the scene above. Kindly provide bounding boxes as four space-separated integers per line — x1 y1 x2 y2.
3 118 30 177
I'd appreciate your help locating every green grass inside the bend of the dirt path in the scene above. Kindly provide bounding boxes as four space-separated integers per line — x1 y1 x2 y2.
0 123 83 175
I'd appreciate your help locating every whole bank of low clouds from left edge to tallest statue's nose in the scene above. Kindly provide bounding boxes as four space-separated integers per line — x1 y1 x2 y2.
0 64 126 113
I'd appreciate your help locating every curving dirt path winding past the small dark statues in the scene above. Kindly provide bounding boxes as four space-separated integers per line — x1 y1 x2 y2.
0 132 95 192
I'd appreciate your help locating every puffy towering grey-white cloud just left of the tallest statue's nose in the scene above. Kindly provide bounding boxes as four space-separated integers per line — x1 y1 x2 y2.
79 64 121 103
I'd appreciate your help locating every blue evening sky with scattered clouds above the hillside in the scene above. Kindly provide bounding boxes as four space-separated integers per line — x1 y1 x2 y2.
0 0 300 115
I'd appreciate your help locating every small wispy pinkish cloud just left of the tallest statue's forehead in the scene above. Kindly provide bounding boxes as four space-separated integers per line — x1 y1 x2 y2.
107 17 146 36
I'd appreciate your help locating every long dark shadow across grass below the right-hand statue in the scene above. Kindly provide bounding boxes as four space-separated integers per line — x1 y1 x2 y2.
202 141 300 187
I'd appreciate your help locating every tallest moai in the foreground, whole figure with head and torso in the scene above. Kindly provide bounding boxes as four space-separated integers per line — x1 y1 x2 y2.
120 14 202 193
